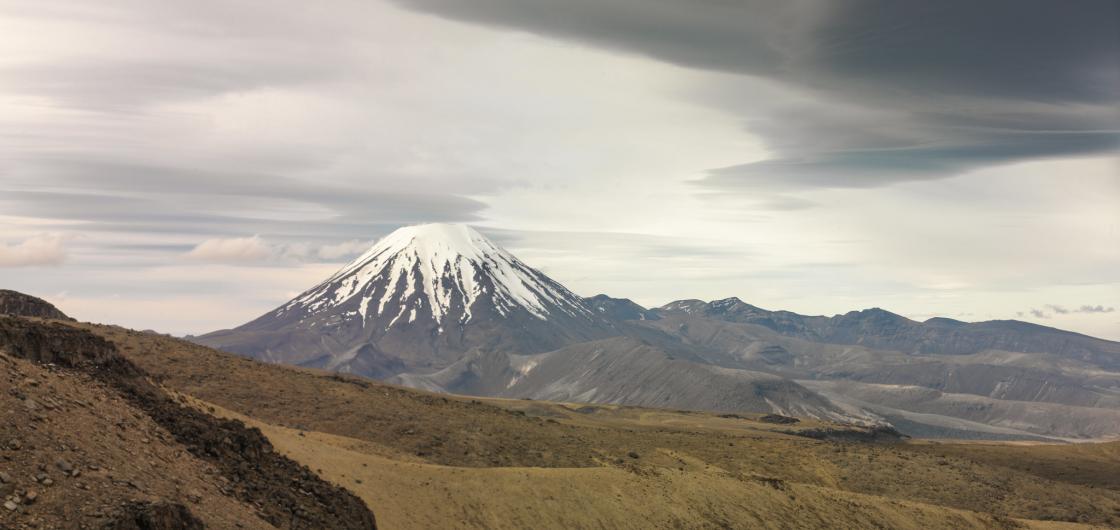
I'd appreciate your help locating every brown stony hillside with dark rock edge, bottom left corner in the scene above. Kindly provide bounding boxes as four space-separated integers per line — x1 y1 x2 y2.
0 316 374 529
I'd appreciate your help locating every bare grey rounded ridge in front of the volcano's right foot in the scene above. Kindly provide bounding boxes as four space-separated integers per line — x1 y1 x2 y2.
389 336 864 425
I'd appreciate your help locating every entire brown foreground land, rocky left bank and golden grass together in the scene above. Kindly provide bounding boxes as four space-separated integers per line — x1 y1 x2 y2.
0 302 1120 529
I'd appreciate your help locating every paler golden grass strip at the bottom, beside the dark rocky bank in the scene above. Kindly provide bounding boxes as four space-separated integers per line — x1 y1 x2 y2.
200 403 1016 529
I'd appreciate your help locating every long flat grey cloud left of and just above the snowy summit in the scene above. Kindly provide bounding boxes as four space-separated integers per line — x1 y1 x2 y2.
0 159 484 238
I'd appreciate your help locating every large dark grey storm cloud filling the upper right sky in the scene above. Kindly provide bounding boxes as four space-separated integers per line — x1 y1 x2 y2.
398 0 1120 188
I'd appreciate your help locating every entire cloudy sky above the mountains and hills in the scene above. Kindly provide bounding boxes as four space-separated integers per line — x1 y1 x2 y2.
0 0 1120 340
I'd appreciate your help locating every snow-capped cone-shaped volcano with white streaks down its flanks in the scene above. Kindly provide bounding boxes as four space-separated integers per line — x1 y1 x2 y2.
200 224 617 376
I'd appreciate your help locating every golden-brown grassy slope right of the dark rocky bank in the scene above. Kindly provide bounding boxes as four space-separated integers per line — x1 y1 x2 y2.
82 326 1120 529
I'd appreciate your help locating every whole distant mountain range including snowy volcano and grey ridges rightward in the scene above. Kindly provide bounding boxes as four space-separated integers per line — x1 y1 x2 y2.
194 224 1120 438
